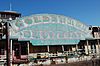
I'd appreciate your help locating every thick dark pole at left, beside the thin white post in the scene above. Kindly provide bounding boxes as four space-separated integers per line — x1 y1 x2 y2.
6 22 10 66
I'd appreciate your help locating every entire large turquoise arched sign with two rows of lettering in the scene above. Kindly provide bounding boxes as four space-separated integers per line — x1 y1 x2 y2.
10 14 92 45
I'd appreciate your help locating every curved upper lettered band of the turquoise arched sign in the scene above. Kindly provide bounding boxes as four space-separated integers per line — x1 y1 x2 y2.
11 14 88 32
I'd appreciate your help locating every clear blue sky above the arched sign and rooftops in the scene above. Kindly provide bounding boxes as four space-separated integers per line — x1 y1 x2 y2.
0 0 100 26
